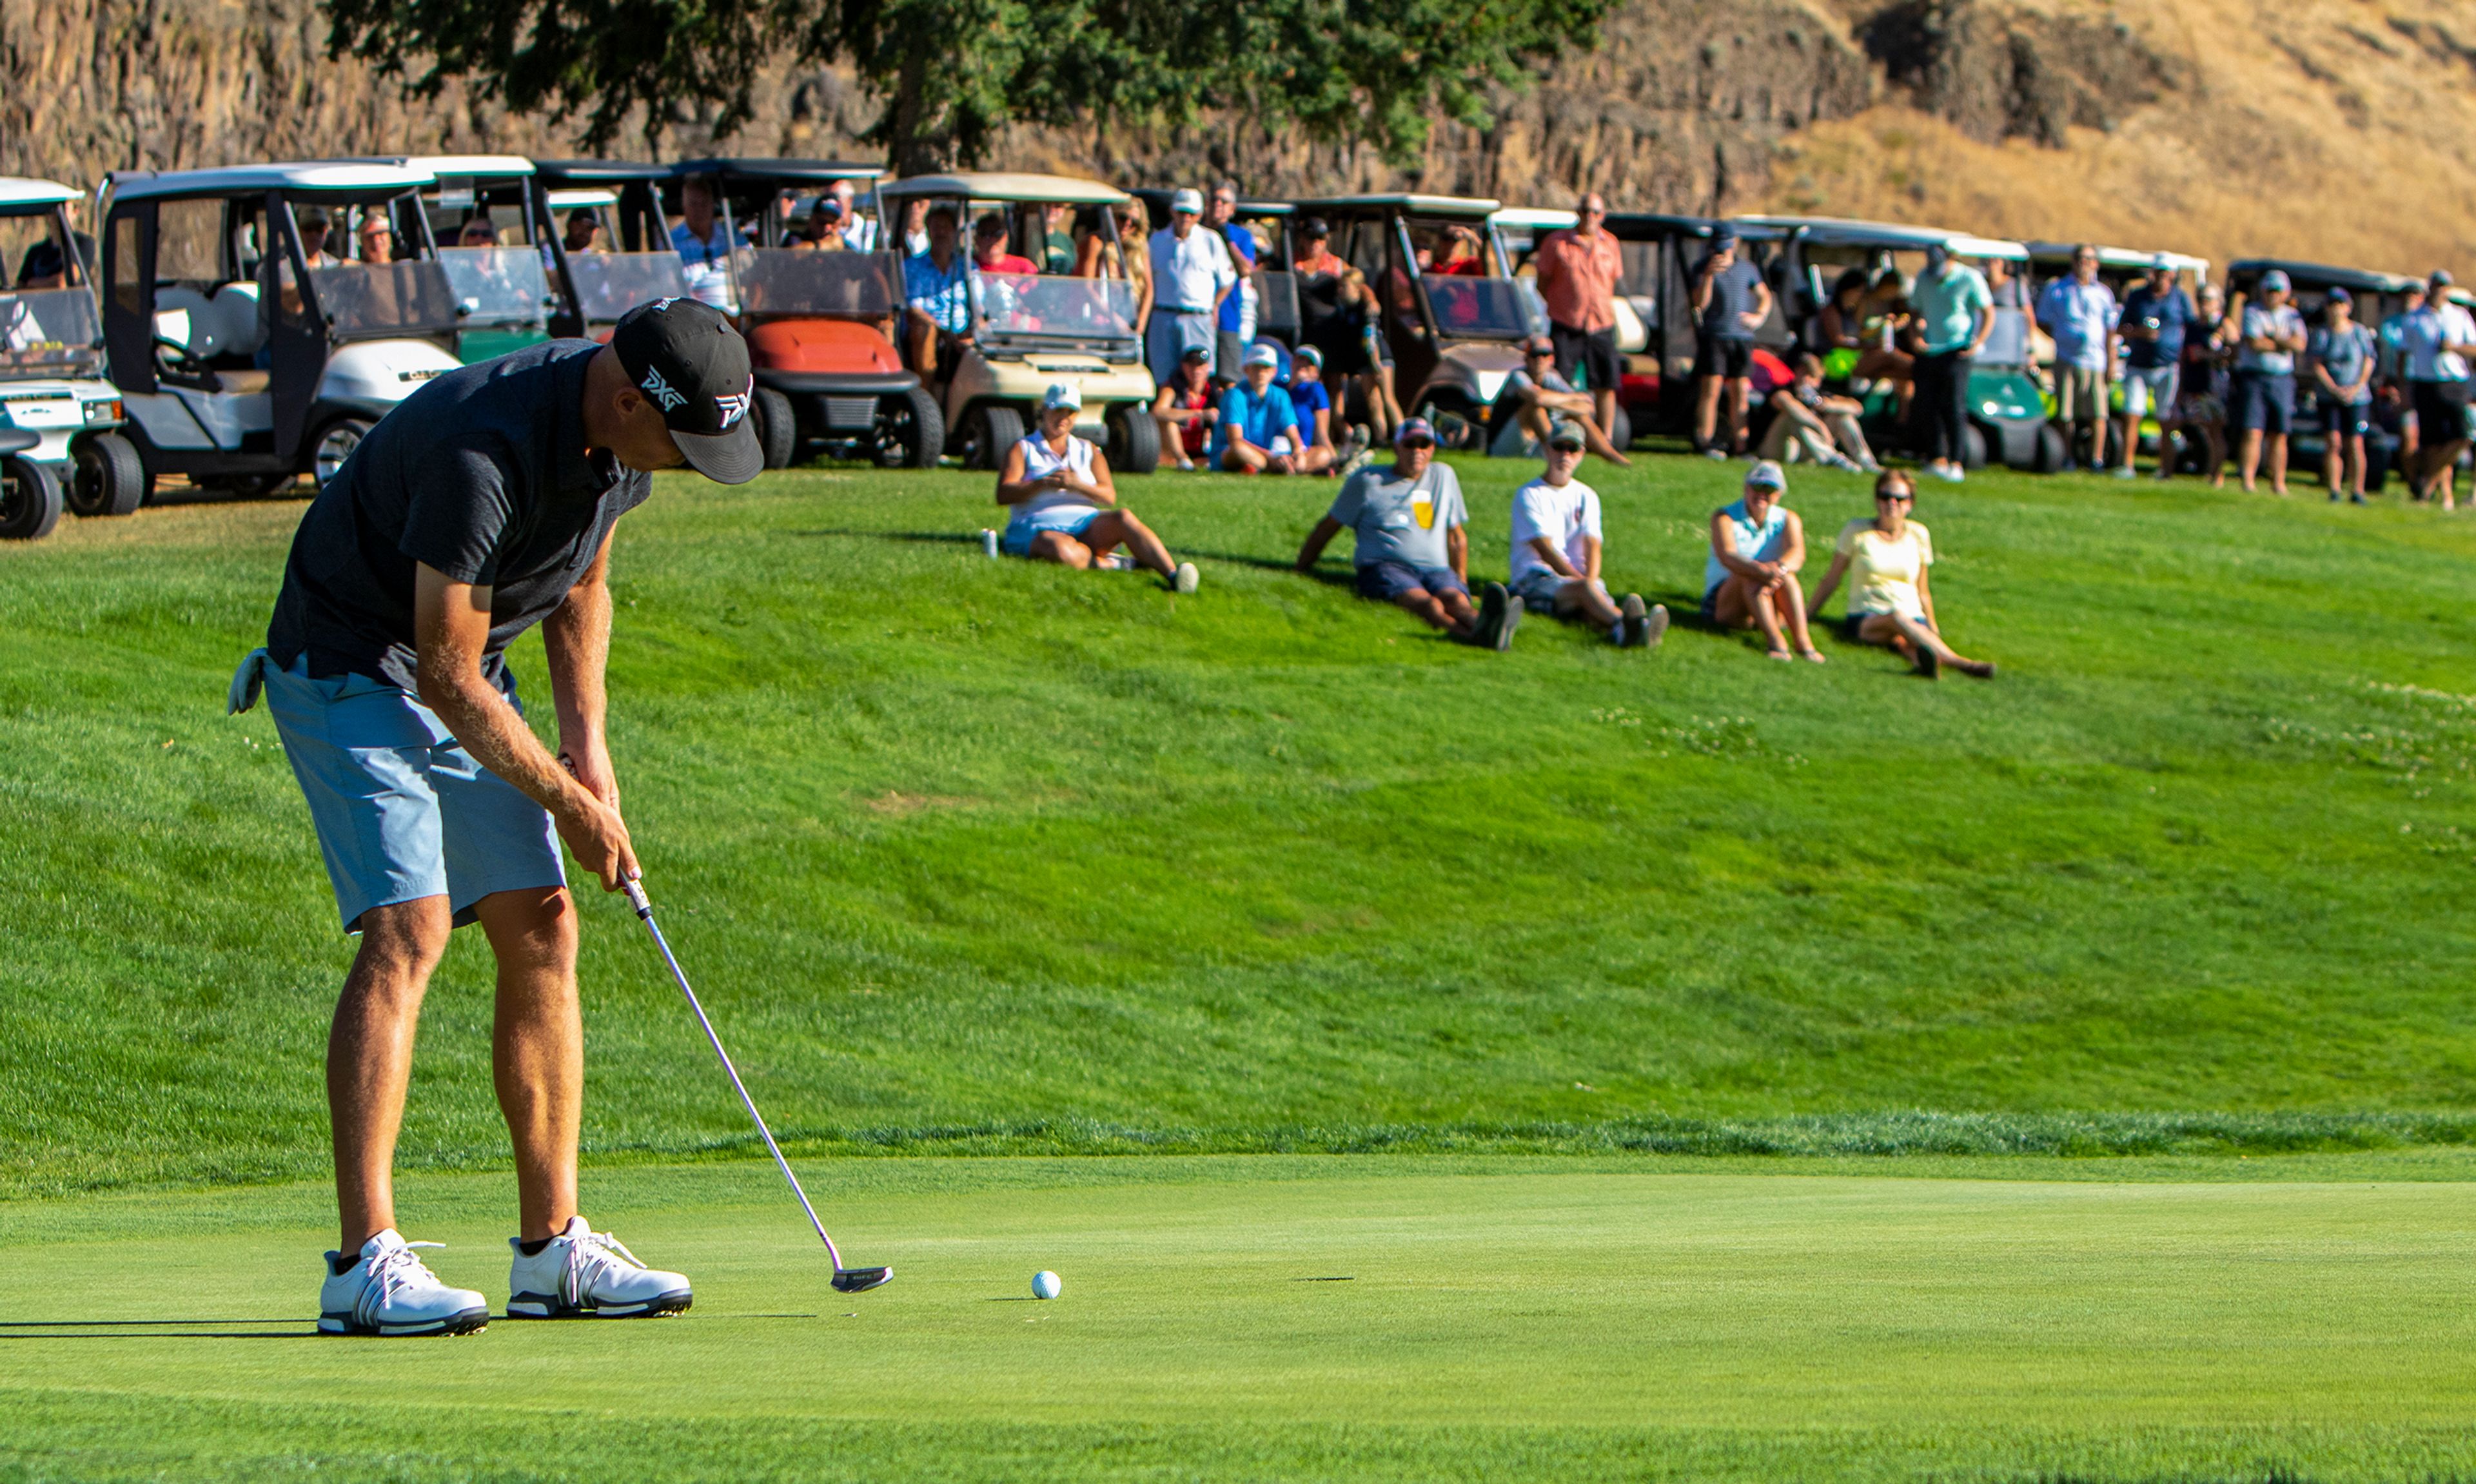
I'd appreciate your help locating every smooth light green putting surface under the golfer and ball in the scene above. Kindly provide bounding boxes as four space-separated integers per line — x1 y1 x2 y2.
0 1157 2476 1479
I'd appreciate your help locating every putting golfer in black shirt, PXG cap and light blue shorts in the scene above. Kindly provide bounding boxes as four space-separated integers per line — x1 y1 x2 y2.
230 300 763 1335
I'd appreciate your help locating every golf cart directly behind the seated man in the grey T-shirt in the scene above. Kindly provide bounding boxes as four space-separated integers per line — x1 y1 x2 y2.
1297 196 1530 449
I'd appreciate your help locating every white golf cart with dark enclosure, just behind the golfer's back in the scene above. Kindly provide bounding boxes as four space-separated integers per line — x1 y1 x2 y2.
99 164 463 496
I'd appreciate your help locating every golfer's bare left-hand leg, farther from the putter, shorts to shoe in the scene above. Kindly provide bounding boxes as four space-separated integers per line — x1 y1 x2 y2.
327 897 451 1254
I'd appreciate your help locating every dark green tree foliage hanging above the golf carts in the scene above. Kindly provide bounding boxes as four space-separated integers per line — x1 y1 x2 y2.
327 0 1615 171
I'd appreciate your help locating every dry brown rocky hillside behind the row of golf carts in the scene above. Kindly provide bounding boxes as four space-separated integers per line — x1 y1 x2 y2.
0 0 2476 273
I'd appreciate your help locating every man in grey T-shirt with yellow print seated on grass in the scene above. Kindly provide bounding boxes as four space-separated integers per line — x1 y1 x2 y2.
1297 416 1523 649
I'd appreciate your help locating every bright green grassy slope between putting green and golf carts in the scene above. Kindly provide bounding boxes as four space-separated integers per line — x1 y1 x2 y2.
0 458 2476 1192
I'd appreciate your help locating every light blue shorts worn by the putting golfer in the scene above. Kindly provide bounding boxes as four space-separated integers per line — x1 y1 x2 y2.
233 649 567 932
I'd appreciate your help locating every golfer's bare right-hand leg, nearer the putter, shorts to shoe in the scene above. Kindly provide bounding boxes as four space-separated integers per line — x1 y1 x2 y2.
473 887 584 1241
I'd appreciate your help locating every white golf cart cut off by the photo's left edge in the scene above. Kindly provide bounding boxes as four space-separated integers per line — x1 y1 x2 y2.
0 176 146 540
